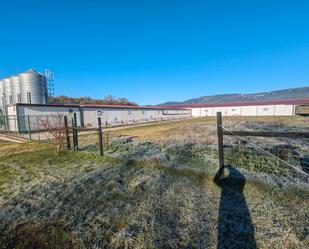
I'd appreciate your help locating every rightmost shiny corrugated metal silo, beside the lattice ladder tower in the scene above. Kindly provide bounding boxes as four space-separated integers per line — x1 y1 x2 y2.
19 69 47 104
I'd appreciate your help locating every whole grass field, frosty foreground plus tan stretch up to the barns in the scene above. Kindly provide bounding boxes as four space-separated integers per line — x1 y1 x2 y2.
0 117 309 248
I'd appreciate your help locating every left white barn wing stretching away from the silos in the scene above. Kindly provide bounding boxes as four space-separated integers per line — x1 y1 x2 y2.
7 104 191 132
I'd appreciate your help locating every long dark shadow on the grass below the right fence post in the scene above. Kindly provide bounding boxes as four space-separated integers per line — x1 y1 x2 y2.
214 166 257 249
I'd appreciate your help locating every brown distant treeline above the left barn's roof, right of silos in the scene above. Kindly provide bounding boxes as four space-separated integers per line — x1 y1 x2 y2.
49 95 137 106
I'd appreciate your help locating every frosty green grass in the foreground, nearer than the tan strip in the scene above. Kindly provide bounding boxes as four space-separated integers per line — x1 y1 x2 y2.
0 141 309 249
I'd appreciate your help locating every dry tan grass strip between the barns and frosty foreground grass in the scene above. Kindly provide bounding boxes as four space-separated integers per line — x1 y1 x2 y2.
76 116 309 144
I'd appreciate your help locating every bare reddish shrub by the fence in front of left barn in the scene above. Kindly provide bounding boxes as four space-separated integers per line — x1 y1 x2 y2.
41 113 66 155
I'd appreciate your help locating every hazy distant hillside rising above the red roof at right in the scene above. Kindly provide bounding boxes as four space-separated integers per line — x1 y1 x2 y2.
160 87 309 105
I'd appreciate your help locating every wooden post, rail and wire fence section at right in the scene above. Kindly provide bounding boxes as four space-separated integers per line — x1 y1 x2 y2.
217 113 309 188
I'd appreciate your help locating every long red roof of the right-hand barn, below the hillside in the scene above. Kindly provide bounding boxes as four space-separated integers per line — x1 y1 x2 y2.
160 99 309 108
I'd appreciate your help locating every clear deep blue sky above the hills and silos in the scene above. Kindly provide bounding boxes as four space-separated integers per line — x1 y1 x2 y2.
0 0 309 104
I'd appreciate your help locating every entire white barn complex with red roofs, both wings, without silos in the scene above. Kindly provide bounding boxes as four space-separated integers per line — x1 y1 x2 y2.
2 99 309 132
